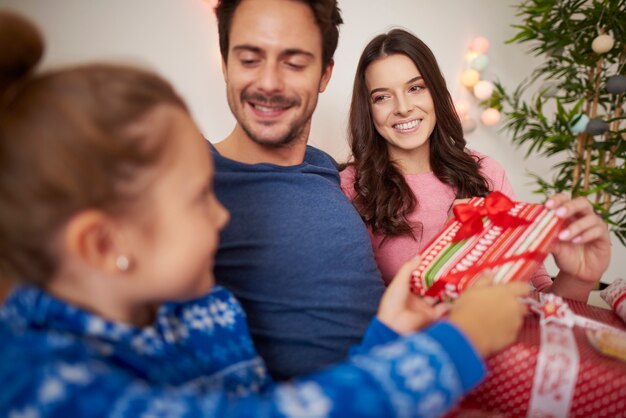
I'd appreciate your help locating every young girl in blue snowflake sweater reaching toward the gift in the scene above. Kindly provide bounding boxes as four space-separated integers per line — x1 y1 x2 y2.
0 14 527 417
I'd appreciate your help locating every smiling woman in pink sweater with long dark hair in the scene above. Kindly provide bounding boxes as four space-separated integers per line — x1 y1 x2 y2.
341 29 610 301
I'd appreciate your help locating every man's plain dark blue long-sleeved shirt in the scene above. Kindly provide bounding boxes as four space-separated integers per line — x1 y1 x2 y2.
211 146 384 380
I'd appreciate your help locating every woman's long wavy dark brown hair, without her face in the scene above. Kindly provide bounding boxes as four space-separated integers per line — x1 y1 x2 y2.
348 29 489 242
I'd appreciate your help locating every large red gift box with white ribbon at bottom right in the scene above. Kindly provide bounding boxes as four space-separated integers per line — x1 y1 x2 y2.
449 300 626 418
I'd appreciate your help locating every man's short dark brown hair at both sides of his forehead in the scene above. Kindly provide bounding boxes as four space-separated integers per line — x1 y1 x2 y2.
215 0 343 68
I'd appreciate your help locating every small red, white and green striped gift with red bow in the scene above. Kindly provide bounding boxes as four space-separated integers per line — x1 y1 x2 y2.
411 192 564 299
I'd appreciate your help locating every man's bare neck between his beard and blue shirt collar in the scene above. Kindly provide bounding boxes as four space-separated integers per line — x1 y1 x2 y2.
214 124 308 167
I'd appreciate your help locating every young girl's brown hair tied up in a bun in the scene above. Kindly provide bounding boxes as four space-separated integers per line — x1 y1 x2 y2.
0 13 186 283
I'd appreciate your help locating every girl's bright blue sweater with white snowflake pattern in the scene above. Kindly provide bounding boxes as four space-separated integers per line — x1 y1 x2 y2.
0 287 485 418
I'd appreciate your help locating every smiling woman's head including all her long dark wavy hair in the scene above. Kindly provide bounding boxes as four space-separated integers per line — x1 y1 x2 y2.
348 29 488 238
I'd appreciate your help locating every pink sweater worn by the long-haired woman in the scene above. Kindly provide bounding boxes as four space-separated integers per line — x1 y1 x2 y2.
340 152 552 290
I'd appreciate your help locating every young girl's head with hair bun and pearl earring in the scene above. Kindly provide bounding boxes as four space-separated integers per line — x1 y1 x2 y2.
0 14 228 316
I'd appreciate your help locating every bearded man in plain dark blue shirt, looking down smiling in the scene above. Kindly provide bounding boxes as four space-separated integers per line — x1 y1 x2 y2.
214 0 383 379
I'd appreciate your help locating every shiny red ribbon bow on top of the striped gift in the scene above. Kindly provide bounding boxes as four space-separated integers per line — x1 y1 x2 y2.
452 192 529 242
